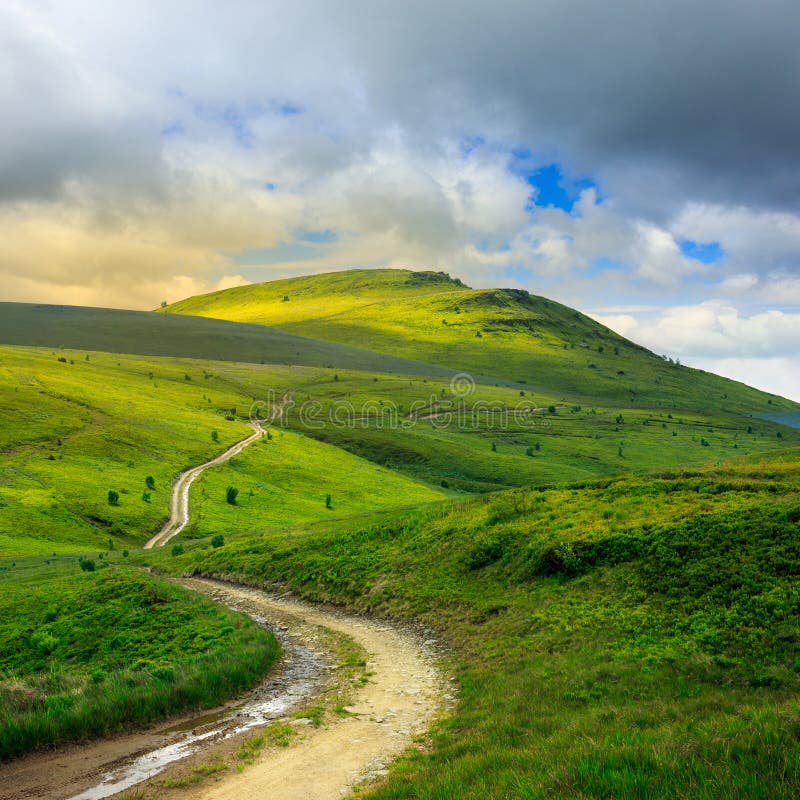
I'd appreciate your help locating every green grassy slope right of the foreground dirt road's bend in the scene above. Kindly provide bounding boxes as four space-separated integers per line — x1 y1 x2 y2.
147 450 800 800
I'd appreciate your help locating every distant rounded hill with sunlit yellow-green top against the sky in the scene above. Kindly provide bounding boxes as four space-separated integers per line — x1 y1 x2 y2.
159 270 797 413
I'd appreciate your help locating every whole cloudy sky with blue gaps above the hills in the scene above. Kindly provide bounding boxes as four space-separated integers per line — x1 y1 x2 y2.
0 0 800 400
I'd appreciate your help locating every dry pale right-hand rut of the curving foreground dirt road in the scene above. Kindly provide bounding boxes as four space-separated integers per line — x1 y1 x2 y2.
175 581 446 800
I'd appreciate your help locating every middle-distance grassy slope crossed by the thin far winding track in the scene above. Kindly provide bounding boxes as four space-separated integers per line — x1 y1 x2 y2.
0 347 800 555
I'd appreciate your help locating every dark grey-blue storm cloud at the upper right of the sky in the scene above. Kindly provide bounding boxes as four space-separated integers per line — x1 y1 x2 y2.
322 0 800 216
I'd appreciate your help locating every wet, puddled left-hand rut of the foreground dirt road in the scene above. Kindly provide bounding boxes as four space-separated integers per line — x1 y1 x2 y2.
70 614 326 800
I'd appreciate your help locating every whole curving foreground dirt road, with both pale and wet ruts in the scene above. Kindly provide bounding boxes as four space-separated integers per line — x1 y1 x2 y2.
0 579 449 800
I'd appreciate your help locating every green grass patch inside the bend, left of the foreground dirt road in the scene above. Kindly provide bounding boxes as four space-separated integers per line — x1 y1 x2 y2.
0 556 279 759
